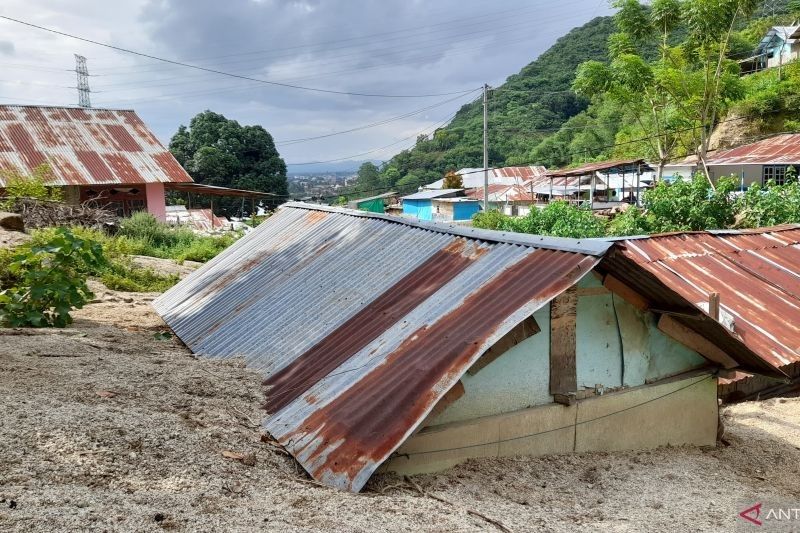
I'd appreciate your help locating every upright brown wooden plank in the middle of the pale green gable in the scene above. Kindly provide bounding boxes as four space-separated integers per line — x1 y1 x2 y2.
550 287 578 394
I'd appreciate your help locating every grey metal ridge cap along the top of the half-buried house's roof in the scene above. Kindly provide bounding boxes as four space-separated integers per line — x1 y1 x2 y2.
280 202 614 257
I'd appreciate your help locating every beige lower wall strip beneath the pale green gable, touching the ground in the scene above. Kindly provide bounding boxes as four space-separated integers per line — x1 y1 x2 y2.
382 374 717 474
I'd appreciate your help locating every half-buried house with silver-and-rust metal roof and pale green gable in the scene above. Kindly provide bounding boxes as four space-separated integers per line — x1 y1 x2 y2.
154 203 784 491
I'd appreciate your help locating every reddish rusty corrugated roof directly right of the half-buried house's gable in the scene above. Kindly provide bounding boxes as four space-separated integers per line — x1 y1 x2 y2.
608 226 800 374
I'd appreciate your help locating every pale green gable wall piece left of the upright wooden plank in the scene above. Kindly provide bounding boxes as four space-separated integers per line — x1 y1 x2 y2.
430 305 553 425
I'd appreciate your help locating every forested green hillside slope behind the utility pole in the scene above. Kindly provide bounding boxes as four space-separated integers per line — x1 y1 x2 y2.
384 17 614 186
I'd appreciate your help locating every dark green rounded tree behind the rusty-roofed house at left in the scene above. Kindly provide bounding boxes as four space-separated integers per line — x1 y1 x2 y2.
169 111 288 216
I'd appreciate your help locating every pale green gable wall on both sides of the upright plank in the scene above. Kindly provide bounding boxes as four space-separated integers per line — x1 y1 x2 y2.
427 275 706 426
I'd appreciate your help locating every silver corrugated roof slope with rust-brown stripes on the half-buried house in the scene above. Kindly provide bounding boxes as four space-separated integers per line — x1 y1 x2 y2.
154 204 610 490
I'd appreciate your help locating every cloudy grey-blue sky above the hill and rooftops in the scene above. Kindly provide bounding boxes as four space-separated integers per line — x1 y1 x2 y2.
0 0 609 163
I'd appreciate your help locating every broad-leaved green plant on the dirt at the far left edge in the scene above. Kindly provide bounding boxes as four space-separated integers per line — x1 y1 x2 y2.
0 228 105 327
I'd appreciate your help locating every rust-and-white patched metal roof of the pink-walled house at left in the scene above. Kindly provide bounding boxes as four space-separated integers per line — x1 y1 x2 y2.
0 105 192 187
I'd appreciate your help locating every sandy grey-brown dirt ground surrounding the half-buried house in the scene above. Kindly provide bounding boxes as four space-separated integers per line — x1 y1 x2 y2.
0 285 800 533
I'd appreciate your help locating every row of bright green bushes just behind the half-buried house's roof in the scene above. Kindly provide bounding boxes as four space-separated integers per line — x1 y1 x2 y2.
473 174 800 238
